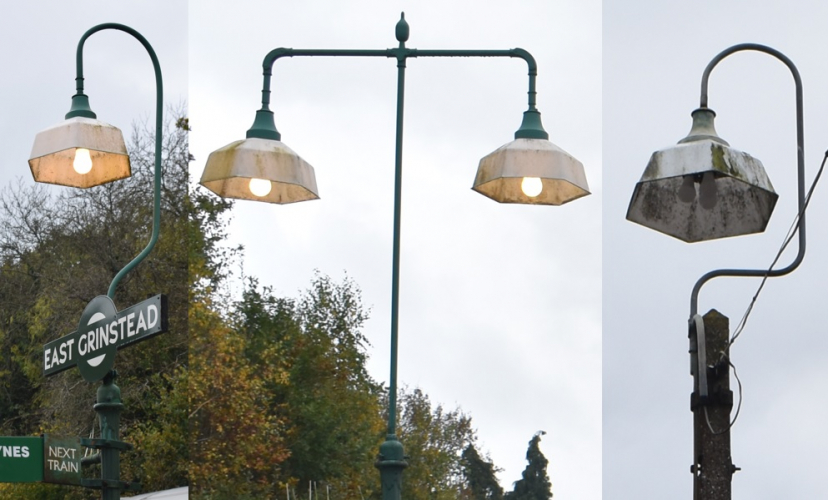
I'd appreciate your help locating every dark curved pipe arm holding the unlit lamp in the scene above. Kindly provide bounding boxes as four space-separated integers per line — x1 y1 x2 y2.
690 43 805 318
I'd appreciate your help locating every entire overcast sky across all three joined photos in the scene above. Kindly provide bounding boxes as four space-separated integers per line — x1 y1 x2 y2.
8 0 828 499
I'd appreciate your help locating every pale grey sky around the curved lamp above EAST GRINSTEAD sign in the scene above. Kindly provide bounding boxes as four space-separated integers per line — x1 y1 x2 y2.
0 0 187 191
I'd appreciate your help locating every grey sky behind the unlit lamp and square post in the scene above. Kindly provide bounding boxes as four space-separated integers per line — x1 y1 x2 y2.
603 0 828 500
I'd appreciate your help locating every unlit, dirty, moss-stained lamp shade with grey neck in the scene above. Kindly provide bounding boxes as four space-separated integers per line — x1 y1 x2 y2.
627 108 778 242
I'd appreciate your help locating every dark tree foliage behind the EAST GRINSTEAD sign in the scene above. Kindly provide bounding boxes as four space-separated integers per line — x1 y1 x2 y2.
0 110 190 499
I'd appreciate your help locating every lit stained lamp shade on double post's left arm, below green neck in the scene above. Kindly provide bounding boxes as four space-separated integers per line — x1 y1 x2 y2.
201 137 319 204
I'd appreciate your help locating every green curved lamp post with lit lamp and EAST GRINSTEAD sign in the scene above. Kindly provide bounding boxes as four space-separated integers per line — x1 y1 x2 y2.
29 23 166 500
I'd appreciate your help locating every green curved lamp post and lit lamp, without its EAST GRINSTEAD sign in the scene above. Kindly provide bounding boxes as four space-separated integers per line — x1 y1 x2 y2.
29 23 164 500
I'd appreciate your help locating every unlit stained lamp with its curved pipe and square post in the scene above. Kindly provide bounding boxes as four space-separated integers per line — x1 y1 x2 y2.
627 43 805 500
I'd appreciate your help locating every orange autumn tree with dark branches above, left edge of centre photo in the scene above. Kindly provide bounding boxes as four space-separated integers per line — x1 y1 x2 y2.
187 143 288 500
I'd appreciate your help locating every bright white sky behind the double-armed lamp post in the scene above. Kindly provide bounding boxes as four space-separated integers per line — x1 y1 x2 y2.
189 0 602 499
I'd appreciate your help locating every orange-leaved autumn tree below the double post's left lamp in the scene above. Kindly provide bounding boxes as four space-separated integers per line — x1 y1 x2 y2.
189 276 287 499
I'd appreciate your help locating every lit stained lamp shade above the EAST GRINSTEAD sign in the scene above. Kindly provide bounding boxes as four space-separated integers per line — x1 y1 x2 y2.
29 115 131 188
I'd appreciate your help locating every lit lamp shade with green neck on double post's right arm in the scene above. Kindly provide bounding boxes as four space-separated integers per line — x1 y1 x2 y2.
472 110 589 205
